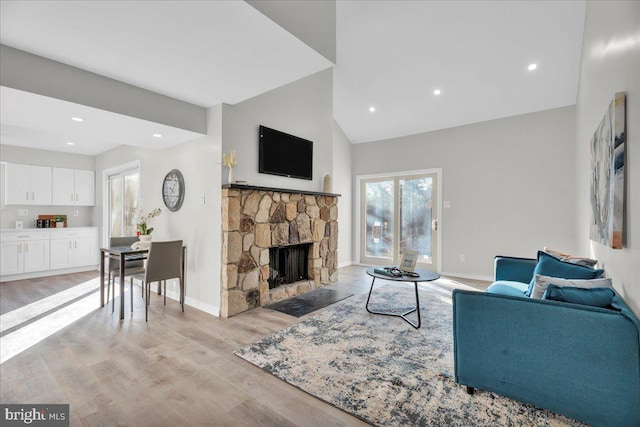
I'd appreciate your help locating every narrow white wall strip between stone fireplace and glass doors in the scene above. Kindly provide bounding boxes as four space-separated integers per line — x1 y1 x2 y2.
331 120 355 267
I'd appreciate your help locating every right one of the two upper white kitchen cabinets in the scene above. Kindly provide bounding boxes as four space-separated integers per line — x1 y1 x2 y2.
52 168 95 206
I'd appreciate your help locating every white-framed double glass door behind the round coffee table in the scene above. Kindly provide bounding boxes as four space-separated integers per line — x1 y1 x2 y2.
360 173 438 271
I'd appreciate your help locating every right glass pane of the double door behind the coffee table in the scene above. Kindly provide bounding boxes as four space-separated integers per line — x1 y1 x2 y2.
399 177 433 263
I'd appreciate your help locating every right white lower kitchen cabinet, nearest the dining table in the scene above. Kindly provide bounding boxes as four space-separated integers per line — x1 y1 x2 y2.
51 228 99 270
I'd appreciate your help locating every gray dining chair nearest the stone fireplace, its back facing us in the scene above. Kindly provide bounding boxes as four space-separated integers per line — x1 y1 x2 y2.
130 240 184 321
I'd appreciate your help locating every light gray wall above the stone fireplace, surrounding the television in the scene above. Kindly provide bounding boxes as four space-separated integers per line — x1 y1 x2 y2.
222 70 333 191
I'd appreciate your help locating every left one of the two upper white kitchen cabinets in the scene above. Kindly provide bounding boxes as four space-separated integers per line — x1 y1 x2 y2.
4 163 51 205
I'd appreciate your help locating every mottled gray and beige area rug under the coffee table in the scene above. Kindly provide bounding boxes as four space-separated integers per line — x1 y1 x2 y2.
235 285 584 426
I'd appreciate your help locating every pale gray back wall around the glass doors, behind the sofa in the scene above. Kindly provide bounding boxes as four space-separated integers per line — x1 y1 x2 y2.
352 107 575 279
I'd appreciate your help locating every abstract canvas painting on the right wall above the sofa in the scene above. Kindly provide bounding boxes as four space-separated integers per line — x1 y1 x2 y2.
589 92 627 249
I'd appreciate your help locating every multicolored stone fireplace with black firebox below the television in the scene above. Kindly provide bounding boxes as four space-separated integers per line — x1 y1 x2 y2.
220 184 339 317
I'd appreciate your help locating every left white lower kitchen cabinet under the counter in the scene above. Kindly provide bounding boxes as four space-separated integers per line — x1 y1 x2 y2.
0 230 50 276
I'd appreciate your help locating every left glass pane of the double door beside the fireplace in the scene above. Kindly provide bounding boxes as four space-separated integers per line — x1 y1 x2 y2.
365 180 394 259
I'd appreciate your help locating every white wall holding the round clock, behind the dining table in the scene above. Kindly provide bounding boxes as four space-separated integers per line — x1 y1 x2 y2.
95 106 222 316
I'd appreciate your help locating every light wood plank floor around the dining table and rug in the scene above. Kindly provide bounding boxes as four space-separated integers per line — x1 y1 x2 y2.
0 266 487 427
